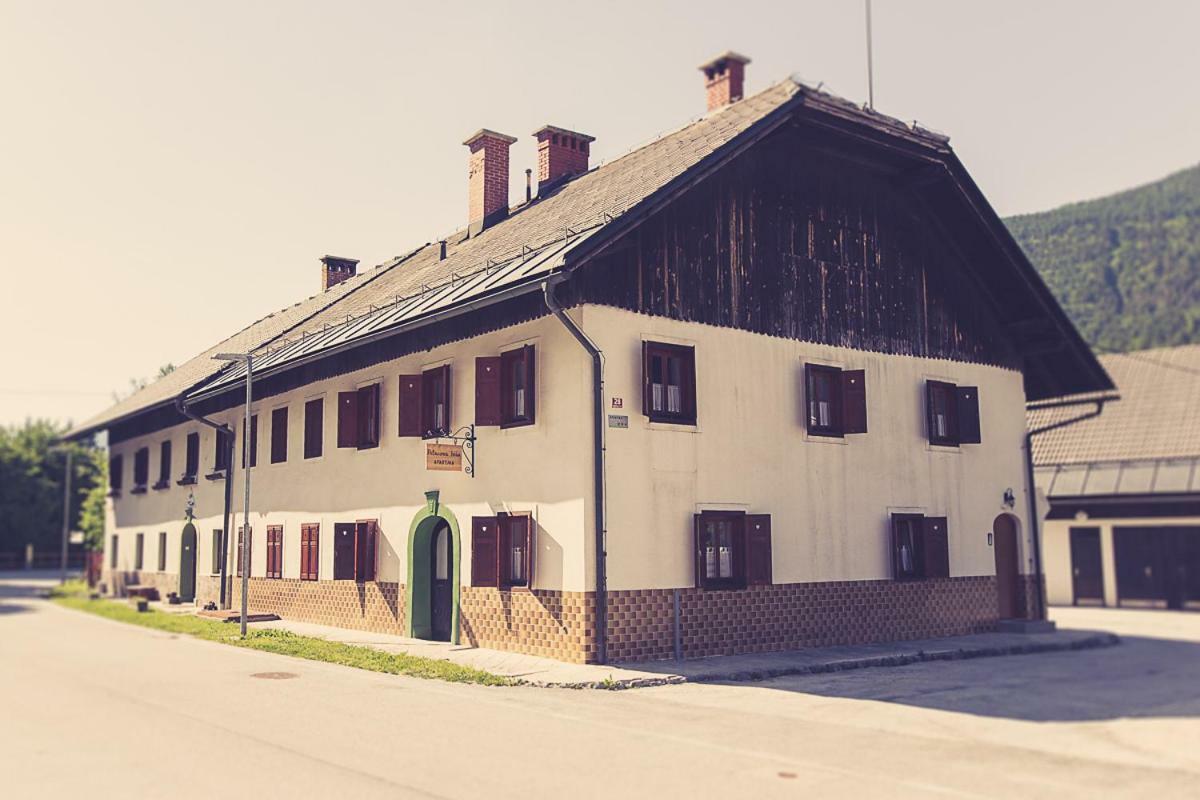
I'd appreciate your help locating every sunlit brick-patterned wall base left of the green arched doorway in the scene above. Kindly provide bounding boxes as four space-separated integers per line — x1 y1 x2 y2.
231 577 407 636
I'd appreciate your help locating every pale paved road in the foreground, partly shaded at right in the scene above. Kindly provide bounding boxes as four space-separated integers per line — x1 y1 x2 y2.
0 579 1200 800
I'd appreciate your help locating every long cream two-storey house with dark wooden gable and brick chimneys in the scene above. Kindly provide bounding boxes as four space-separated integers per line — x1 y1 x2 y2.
73 54 1111 661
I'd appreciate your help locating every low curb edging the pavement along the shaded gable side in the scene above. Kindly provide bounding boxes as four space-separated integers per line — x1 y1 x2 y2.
540 633 1121 691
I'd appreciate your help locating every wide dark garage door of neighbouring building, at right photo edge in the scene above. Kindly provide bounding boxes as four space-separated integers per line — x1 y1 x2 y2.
1112 525 1200 609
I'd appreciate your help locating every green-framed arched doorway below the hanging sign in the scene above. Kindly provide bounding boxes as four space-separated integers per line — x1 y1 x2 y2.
404 492 462 644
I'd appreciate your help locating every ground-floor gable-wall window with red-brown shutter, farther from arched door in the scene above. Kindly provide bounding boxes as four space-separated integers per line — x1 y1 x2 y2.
692 511 772 589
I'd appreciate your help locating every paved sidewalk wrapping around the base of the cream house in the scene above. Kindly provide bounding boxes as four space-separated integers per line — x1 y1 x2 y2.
253 620 1120 688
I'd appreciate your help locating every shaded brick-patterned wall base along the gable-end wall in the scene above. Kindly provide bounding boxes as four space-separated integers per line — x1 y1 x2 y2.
608 576 998 661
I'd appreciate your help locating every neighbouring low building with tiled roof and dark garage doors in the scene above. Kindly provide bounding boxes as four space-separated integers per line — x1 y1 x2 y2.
1031 344 1200 608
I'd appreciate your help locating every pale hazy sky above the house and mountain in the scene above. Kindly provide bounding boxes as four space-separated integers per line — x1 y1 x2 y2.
0 0 1200 423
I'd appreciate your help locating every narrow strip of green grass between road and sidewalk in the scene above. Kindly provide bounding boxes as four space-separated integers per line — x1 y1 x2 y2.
50 582 520 686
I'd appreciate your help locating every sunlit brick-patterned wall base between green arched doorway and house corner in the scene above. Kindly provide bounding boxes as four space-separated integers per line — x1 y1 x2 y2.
458 587 595 663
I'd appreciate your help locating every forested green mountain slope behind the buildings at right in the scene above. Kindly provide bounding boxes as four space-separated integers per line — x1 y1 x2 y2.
1004 160 1200 353
